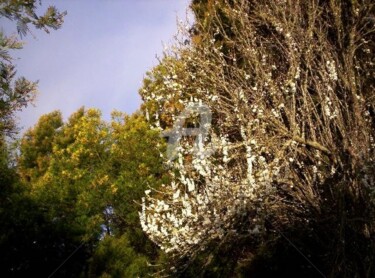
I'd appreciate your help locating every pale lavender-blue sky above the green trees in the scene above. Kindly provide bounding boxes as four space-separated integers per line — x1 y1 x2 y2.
0 0 190 131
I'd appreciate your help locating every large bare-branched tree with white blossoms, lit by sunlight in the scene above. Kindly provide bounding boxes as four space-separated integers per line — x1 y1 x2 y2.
140 0 375 274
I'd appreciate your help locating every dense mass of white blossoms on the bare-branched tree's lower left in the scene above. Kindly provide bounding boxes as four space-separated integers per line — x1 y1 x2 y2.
140 92 271 254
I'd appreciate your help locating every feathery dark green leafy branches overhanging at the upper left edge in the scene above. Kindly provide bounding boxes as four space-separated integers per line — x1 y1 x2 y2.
0 0 66 135
